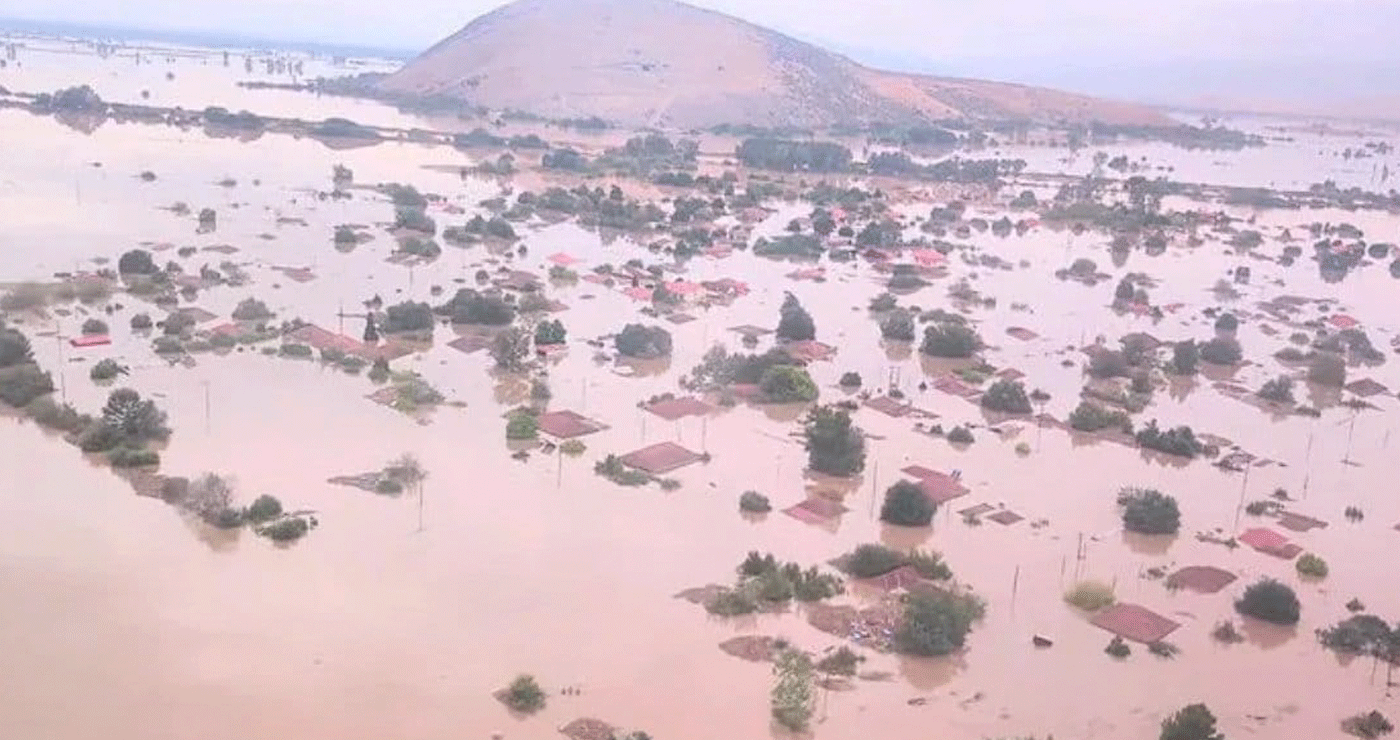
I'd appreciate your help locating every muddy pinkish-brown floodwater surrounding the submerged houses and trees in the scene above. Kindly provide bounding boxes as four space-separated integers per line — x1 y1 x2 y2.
0 41 1400 740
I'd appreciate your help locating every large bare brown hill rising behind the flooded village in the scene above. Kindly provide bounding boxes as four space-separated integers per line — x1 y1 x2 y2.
379 0 1169 129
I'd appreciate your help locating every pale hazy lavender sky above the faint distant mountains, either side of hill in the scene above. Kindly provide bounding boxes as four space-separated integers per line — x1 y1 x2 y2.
0 0 1400 62
